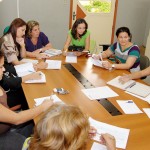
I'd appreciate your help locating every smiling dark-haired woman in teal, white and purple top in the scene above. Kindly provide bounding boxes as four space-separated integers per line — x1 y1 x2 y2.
93 27 140 72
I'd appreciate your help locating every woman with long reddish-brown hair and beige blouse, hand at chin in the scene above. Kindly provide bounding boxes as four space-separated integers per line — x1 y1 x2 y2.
1 18 48 69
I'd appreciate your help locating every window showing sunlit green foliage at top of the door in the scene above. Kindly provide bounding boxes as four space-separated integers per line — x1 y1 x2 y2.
79 0 111 13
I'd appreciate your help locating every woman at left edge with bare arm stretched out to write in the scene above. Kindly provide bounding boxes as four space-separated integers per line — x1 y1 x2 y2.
0 51 53 150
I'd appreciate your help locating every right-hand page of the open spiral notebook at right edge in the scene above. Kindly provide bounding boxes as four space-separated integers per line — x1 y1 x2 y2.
126 82 150 97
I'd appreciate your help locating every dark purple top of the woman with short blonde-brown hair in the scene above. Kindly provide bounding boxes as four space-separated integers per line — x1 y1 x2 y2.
25 32 49 52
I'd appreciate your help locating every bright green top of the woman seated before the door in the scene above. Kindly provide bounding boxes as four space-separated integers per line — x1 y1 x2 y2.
68 30 90 46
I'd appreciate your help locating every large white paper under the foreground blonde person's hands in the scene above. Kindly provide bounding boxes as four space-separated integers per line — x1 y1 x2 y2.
89 117 130 149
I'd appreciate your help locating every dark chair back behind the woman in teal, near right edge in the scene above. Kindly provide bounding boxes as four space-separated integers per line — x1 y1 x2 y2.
140 55 150 79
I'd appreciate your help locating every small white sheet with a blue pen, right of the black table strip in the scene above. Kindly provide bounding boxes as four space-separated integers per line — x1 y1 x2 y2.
117 100 143 114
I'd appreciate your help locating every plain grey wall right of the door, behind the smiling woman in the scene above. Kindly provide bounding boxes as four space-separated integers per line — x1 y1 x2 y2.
116 0 150 45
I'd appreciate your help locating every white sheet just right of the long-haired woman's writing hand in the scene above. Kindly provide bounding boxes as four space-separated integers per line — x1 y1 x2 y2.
46 60 61 69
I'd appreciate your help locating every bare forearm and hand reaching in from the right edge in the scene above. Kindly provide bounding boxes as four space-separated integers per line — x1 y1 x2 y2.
119 67 150 83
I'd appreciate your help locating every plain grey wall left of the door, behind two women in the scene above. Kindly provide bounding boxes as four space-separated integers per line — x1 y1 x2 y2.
0 0 70 49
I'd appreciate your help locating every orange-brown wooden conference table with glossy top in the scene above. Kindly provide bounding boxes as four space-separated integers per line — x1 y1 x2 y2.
22 55 150 150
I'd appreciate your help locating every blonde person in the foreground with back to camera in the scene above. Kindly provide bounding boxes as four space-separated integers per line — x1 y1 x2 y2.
23 103 116 150
